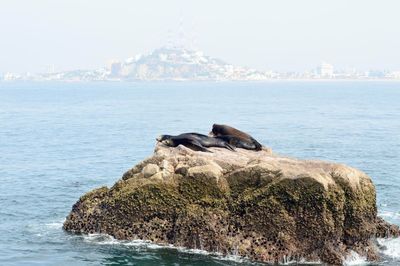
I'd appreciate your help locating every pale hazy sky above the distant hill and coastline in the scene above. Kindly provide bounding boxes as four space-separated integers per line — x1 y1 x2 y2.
0 0 400 72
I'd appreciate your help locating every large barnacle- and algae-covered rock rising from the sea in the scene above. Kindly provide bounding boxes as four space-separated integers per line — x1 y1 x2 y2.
64 145 399 265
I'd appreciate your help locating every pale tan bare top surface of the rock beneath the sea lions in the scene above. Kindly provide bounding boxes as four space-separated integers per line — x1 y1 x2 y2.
153 144 371 189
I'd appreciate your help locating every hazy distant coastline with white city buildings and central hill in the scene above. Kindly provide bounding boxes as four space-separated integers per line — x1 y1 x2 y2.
0 45 400 81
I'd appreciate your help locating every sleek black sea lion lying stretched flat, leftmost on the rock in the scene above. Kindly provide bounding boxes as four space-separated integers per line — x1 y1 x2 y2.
157 133 235 152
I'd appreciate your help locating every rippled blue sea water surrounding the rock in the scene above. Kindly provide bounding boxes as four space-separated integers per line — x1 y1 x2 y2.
0 81 400 265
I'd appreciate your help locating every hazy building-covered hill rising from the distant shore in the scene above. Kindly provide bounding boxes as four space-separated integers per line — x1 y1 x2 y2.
109 47 268 80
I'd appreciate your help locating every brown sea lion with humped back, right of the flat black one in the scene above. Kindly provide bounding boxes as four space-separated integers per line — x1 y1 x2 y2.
210 124 262 151
